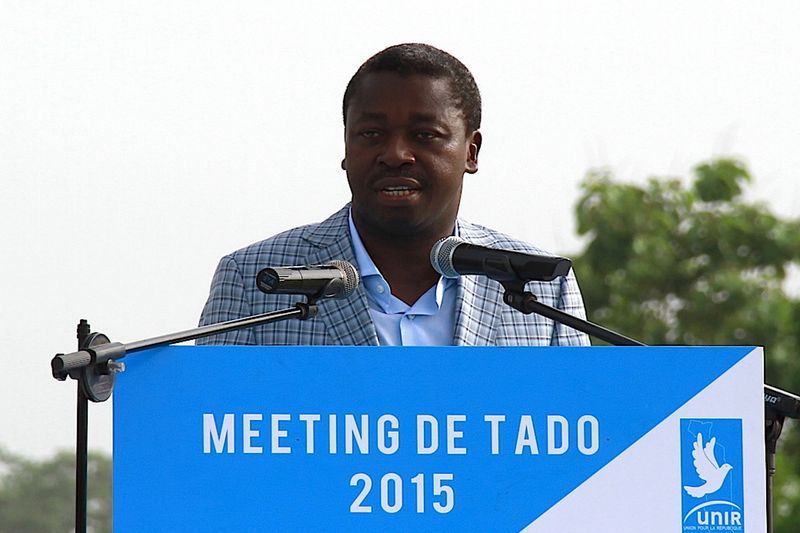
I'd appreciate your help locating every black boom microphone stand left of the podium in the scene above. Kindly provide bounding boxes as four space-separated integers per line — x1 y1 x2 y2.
50 297 318 533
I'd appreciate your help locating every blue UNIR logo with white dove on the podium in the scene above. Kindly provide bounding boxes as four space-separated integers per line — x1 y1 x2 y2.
680 418 744 532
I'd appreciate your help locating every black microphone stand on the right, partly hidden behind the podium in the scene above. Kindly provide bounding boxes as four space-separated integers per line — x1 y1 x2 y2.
501 280 800 533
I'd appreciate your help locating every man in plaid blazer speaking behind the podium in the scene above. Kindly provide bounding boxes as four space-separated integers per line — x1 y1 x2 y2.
198 44 588 345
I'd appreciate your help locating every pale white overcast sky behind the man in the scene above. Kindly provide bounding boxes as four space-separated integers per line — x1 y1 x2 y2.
0 0 800 456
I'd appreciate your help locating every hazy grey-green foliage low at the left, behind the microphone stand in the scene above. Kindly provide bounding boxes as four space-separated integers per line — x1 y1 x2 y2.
0 447 111 533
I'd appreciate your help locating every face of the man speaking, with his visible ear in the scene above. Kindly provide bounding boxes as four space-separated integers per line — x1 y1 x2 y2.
344 73 481 238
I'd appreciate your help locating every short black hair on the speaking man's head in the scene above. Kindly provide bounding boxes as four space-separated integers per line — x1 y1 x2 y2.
342 43 481 134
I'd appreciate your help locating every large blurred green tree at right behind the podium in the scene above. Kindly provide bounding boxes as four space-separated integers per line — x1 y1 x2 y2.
574 159 800 533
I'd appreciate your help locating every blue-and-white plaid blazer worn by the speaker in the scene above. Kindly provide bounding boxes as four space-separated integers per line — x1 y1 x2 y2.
197 205 589 346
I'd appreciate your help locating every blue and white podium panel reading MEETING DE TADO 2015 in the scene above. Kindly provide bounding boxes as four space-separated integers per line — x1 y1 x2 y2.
114 346 766 533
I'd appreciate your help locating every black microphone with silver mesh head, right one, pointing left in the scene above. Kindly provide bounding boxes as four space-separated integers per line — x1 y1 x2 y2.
431 237 572 283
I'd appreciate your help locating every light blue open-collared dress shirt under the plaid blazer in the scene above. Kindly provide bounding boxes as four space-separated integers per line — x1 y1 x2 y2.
349 212 458 346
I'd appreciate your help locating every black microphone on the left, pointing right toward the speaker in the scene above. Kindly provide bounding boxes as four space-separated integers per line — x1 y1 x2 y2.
256 260 358 299
